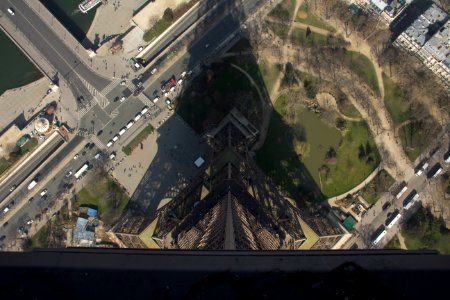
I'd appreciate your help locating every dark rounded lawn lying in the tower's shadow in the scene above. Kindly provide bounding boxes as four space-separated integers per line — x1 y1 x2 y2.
175 64 263 134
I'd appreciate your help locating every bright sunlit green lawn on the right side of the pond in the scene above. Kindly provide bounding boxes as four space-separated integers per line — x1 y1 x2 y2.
320 122 380 198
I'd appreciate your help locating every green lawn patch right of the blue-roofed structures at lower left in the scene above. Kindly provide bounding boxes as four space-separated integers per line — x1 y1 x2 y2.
77 173 130 222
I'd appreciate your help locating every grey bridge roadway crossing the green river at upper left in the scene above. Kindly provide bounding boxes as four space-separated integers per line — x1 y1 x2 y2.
7 0 110 90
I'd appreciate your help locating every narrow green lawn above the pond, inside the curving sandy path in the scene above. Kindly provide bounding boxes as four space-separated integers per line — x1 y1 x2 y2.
345 51 380 95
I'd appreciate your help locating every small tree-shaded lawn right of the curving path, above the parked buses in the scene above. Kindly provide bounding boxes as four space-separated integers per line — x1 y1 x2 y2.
399 122 427 162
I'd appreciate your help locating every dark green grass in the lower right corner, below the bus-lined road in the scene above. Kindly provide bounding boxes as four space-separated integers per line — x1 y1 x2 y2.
402 207 450 254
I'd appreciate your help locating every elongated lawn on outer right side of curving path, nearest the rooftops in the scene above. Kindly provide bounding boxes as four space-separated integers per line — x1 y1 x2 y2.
383 73 410 125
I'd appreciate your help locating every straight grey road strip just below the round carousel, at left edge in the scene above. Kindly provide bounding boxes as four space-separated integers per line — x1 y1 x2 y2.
0 135 64 205
